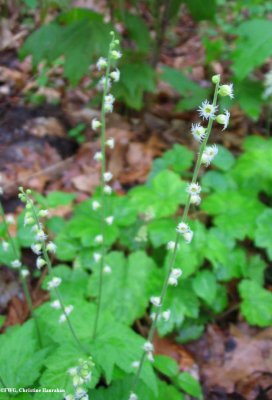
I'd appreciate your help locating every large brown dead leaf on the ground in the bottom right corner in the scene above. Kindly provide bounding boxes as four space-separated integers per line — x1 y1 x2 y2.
192 326 272 399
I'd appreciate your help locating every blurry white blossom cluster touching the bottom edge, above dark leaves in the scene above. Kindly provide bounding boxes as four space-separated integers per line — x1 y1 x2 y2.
65 357 94 400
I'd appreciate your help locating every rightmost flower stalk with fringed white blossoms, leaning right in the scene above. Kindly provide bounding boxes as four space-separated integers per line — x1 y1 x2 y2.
129 75 233 400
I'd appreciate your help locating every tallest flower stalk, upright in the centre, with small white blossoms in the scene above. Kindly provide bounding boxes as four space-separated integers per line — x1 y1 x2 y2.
92 32 121 339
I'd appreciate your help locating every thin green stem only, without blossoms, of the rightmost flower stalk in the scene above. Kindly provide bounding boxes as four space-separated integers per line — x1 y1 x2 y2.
132 82 219 392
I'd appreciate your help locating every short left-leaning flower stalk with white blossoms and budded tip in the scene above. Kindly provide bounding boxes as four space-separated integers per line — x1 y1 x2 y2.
19 187 86 353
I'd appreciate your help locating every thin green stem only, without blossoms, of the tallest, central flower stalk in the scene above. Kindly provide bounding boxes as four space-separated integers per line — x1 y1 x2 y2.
93 36 114 340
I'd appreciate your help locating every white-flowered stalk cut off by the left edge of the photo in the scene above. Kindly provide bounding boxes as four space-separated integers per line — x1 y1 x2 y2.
0 202 42 346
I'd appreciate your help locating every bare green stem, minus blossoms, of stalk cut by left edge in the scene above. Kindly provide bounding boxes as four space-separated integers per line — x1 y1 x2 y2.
0 202 42 347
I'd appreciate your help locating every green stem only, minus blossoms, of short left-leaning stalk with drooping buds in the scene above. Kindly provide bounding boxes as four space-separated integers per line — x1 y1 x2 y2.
31 203 87 354
